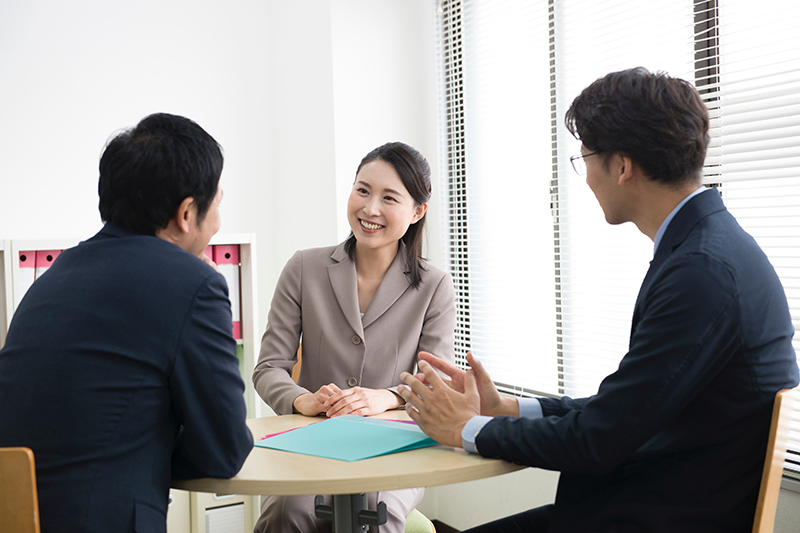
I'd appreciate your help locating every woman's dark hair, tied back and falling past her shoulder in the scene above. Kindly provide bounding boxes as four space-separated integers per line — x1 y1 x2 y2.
344 142 431 289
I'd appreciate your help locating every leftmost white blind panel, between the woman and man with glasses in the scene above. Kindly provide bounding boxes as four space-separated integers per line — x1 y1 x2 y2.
449 0 556 392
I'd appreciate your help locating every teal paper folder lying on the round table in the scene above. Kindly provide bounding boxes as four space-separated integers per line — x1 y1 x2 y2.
255 415 438 461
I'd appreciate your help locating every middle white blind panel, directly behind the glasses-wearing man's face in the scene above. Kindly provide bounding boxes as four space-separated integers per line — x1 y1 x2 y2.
555 0 694 397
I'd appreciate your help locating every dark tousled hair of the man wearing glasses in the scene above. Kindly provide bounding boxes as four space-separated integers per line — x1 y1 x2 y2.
565 67 710 184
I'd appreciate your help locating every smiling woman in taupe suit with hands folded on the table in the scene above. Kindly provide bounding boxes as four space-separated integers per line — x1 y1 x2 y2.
253 143 455 533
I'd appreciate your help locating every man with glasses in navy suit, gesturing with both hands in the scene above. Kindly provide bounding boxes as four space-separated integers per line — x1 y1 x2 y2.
401 68 798 533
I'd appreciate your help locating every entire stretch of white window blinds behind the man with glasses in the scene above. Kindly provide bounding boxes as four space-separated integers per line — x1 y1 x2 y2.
439 0 800 473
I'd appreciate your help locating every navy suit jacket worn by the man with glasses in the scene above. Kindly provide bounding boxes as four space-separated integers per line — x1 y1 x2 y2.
476 190 798 533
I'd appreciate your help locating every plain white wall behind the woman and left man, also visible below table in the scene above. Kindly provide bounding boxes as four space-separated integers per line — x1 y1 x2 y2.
0 0 800 533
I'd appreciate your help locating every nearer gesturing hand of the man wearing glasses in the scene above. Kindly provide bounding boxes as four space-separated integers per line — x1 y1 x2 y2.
397 360 480 447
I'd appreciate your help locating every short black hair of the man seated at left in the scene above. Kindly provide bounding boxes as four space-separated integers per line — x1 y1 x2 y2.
98 113 223 235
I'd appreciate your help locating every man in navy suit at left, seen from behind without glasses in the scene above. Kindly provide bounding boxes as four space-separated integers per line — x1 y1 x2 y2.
0 114 253 533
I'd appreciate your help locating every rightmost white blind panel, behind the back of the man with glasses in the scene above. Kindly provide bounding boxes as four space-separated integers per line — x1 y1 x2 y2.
704 0 800 474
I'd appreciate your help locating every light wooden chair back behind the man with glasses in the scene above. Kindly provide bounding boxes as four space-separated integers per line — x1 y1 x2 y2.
753 389 795 533
